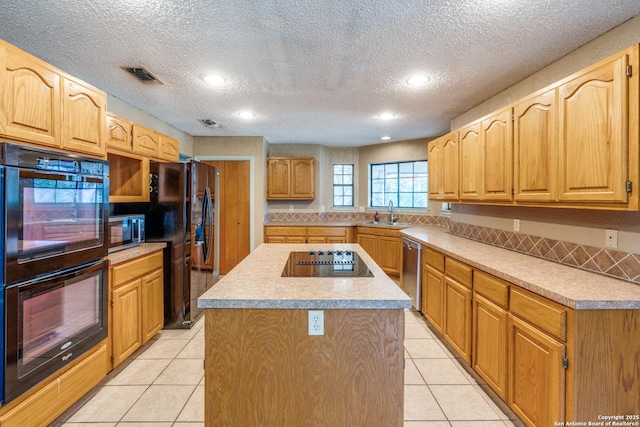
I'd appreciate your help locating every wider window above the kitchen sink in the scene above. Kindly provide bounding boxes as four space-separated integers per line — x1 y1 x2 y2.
369 160 428 209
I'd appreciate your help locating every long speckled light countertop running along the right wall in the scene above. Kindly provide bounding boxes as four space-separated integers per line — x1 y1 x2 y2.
400 226 640 309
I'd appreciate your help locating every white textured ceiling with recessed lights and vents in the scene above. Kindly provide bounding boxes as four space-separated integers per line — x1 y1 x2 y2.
0 0 640 146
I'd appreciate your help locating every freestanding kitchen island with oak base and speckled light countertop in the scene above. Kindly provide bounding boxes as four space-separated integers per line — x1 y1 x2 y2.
198 244 411 427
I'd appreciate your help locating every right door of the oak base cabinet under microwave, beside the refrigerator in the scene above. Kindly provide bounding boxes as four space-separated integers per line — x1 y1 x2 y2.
140 270 164 344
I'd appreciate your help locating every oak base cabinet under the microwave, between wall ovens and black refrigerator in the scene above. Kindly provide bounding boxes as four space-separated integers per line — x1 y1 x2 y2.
110 251 164 368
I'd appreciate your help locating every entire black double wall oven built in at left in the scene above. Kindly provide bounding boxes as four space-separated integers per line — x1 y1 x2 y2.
0 142 109 403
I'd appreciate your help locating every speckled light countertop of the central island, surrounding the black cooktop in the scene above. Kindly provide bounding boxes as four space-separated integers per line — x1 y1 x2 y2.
198 243 411 309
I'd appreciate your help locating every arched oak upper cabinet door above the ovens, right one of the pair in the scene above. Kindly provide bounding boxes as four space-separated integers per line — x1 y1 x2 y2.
61 77 107 156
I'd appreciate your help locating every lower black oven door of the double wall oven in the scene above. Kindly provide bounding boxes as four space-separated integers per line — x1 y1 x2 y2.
4 260 108 402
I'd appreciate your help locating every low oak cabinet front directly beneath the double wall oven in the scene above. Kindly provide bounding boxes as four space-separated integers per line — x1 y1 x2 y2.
0 340 110 427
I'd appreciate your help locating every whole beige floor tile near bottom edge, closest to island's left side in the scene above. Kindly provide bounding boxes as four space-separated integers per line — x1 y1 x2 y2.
122 385 195 422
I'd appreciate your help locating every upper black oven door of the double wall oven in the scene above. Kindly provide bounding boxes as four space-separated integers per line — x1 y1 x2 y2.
5 162 109 284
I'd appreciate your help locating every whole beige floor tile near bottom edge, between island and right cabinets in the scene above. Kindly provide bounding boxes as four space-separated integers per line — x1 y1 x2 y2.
429 384 502 427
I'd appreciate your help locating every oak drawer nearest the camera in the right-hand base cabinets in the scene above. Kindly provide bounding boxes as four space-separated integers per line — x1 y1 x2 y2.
510 286 568 341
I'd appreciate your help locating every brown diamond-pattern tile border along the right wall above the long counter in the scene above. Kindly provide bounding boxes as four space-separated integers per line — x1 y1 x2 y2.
449 221 640 284
